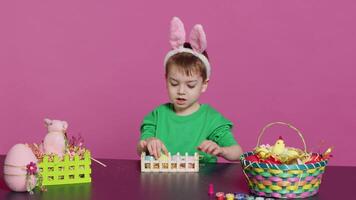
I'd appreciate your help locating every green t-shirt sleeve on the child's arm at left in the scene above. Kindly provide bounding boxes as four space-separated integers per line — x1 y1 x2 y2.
140 110 157 140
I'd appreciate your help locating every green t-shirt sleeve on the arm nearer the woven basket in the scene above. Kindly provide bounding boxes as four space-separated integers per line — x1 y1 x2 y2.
208 111 237 147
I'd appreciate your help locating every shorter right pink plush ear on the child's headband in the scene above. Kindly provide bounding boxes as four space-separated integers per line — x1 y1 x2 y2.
189 24 207 53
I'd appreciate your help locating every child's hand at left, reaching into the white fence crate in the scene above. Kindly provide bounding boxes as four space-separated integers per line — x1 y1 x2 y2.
140 137 168 159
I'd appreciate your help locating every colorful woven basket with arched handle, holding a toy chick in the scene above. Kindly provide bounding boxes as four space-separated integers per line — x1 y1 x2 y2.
240 122 328 198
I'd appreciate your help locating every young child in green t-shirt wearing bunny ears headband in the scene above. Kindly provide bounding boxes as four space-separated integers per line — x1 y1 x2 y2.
137 17 242 162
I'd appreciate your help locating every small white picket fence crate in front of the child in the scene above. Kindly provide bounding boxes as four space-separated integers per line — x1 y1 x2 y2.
141 152 199 172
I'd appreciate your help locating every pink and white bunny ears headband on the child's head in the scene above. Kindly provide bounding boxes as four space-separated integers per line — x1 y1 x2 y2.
164 17 211 78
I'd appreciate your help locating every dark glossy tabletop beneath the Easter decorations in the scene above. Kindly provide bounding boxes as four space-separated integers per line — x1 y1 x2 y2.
0 156 356 200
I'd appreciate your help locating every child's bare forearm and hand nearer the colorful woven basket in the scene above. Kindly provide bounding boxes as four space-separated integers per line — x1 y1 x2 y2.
198 140 243 161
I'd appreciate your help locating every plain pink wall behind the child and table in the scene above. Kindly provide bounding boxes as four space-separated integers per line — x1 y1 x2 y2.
0 0 356 166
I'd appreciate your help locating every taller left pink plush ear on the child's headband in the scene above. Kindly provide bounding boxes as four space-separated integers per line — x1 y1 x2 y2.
169 17 185 49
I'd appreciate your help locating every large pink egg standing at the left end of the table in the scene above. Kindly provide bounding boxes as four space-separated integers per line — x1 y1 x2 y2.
4 144 37 192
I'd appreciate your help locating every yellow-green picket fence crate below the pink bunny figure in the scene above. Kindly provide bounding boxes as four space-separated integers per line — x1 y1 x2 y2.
38 150 91 186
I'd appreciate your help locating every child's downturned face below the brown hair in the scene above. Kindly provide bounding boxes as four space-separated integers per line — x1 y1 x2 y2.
166 65 208 113
